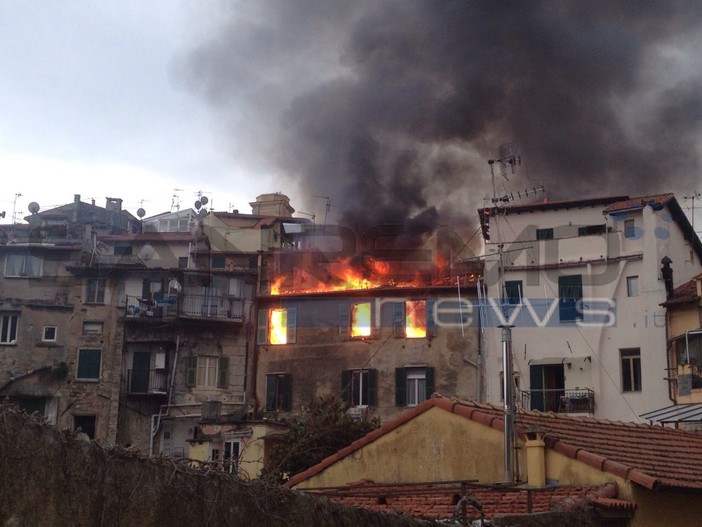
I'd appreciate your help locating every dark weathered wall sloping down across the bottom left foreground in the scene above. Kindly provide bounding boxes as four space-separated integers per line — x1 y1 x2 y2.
0 407 435 527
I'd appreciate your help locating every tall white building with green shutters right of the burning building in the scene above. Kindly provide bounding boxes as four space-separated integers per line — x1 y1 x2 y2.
480 194 702 421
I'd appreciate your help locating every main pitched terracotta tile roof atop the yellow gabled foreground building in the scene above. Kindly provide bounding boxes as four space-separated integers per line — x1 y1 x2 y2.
286 395 702 496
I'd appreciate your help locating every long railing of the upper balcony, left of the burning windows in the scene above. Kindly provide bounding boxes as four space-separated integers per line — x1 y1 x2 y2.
125 293 244 322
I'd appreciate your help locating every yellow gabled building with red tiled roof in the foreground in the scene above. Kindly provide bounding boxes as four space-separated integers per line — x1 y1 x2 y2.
287 396 702 527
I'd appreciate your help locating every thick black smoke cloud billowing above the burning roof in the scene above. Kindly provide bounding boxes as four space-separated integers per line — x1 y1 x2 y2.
184 0 702 234
